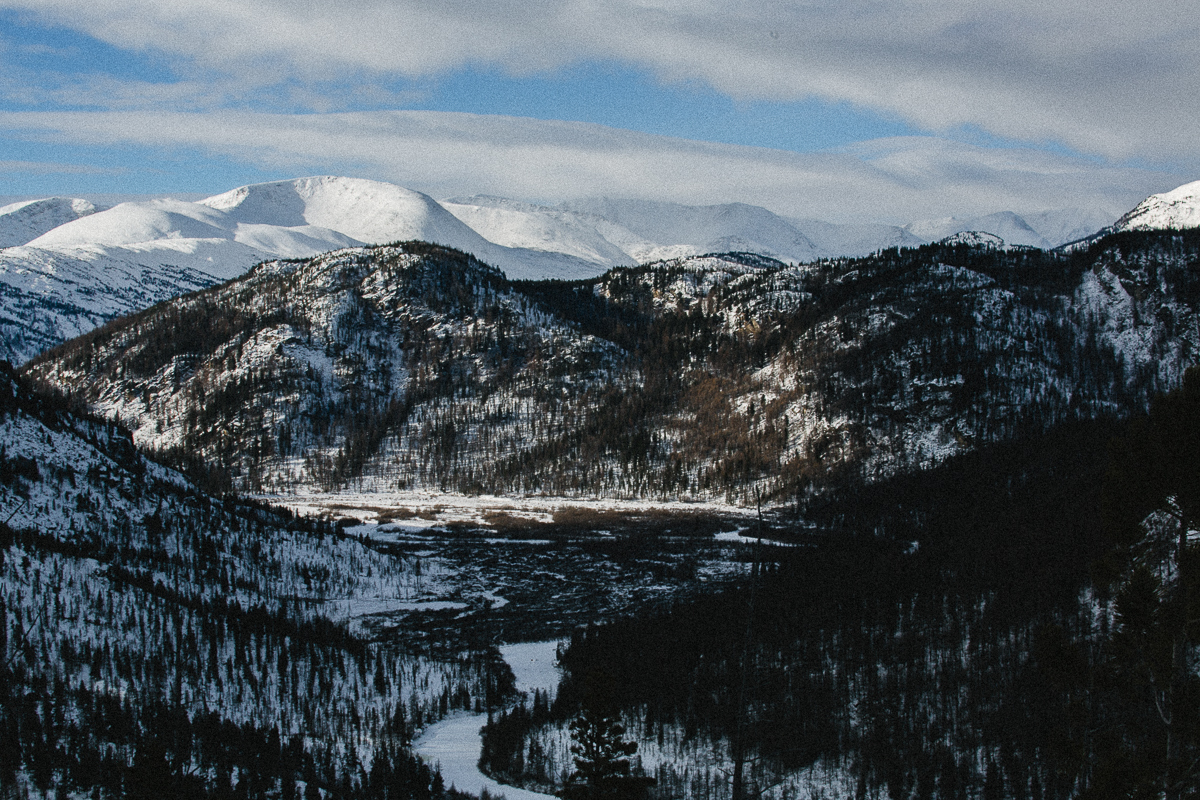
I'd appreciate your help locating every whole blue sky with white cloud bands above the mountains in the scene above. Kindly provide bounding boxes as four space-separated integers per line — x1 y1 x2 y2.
0 0 1200 223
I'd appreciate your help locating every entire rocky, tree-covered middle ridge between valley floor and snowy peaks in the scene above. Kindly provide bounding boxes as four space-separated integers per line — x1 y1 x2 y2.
29 234 1200 501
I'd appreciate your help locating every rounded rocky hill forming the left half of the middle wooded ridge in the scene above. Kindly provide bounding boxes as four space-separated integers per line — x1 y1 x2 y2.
25 243 623 488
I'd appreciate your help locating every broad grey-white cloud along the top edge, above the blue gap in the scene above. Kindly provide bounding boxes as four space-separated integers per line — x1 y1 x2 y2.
0 0 1200 166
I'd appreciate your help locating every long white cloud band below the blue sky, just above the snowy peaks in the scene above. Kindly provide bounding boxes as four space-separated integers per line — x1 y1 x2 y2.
0 112 1184 222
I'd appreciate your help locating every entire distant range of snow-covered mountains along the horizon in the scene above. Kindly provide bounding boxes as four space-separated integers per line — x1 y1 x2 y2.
0 178 1196 363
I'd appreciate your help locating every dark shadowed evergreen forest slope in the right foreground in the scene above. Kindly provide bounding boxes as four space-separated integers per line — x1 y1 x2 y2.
485 381 1200 800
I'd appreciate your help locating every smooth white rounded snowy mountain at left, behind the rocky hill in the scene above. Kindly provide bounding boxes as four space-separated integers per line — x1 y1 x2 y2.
0 178 606 363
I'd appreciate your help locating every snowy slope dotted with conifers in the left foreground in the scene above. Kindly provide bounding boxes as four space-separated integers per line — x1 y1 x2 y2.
0 366 487 798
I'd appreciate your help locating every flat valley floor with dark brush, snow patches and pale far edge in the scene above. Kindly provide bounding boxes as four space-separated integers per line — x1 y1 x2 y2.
263 493 755 652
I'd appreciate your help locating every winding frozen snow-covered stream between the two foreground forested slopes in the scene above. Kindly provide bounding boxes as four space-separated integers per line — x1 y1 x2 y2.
413 640 558 800
